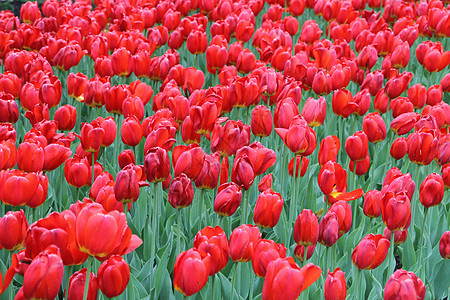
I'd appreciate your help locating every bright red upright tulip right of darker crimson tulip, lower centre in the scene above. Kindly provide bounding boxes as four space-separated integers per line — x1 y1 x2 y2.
253 189 284 228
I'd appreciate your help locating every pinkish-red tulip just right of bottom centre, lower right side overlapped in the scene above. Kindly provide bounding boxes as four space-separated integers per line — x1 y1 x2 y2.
229 224 261 262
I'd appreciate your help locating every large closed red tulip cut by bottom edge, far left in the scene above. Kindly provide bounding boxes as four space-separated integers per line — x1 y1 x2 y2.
22 246 64 299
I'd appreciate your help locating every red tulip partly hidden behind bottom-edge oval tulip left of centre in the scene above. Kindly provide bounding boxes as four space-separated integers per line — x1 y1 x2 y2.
194 226 230 276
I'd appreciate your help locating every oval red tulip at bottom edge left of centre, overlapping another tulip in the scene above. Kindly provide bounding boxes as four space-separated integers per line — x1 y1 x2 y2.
173 249 211 297
